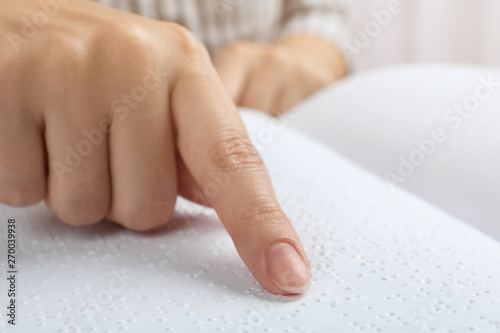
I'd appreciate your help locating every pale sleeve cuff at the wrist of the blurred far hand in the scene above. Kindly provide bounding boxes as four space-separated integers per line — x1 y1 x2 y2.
280 0 352 59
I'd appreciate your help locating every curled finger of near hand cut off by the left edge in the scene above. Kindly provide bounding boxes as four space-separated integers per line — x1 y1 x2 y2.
0 106 46 207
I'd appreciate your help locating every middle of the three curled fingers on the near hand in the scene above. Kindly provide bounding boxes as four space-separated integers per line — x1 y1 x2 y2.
45 101 111 226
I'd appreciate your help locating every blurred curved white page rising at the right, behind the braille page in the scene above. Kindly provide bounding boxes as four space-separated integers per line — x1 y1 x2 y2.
292 65 500 241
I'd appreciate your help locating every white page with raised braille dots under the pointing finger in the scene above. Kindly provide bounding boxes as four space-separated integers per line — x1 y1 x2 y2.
0 112 500 333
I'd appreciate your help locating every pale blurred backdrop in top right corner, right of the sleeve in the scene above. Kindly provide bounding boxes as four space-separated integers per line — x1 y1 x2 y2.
349 0 500 71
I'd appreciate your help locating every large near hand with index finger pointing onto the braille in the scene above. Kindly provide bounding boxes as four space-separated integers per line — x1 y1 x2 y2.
0 0 310 294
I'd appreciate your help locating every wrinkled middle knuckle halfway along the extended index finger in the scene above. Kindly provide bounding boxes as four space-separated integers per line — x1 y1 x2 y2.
208 130 264 172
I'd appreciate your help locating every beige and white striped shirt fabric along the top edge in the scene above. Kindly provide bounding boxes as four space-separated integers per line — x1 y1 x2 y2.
97 0 349 54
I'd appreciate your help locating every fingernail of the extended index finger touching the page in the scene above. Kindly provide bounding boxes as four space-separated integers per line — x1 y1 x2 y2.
266 243 311 294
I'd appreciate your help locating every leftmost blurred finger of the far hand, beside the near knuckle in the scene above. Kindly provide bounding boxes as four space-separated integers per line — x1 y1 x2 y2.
214 41 260 103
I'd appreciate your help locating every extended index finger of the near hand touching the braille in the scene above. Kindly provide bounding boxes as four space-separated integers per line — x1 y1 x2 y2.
172 62 310 294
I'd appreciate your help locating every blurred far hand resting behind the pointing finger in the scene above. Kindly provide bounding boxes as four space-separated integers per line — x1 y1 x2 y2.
214 35 347 116
